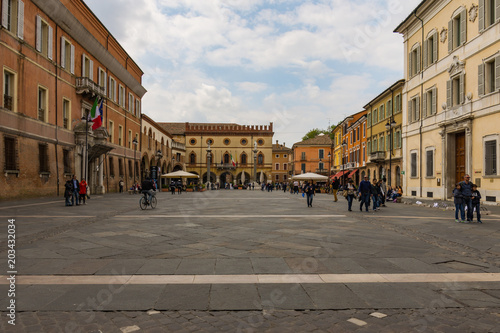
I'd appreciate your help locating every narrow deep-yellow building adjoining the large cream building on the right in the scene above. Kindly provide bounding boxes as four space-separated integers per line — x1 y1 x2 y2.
364 80 405 186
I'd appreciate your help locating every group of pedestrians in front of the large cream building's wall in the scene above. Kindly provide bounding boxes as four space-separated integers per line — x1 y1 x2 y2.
453 175 483 223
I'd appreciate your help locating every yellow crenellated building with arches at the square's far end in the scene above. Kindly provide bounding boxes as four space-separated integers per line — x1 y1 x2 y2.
160 123 274 187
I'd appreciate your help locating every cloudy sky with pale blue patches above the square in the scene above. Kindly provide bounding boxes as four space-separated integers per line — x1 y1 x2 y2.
85 0 421 146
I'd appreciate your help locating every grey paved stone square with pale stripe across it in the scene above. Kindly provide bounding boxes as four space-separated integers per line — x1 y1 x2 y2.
0 190 500 332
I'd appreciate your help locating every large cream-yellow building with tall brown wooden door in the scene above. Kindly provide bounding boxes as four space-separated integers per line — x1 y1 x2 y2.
395 0 500 203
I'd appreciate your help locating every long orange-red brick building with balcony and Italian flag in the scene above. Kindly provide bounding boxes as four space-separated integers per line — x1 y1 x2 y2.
0 0 146 198
